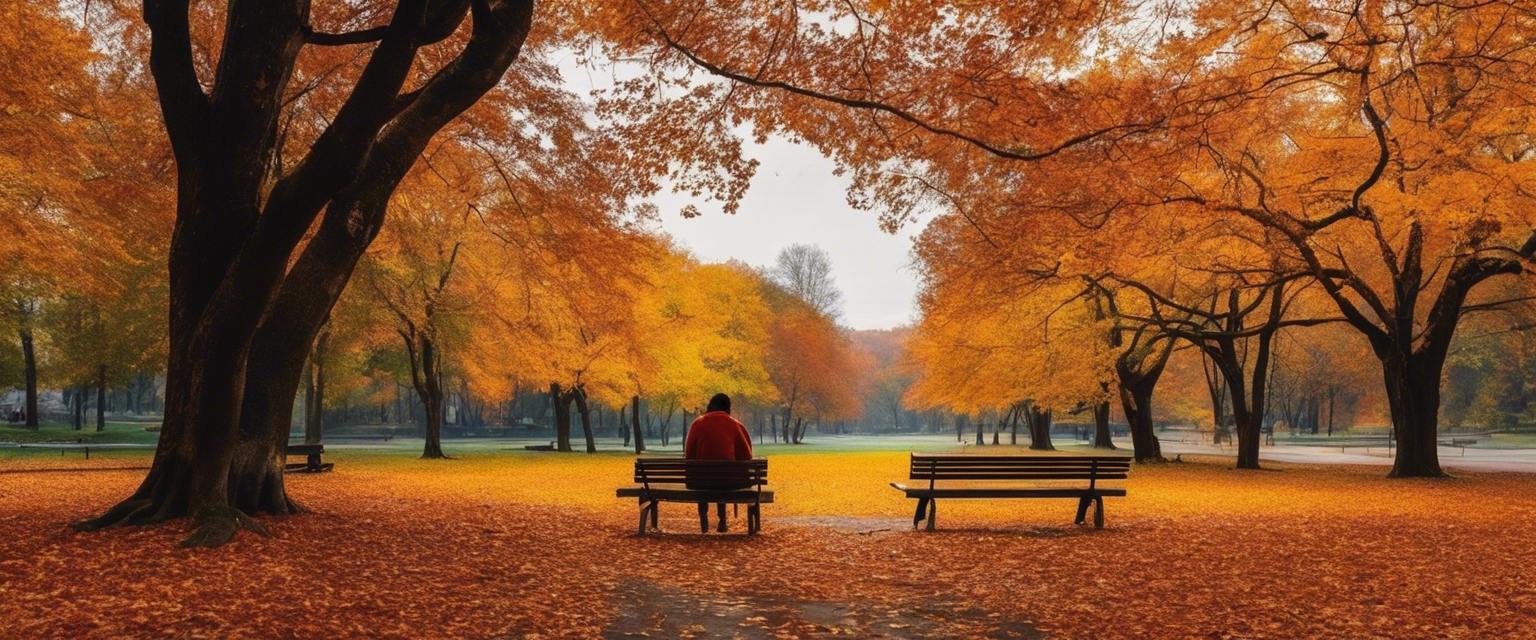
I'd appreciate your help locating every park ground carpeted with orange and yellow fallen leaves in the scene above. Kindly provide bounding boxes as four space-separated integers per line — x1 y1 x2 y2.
0 437 1536 638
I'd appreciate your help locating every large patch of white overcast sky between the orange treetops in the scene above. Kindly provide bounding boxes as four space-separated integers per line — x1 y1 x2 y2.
654 138 922 328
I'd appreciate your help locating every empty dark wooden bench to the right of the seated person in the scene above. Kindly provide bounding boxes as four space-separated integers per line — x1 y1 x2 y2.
891 453 1130 531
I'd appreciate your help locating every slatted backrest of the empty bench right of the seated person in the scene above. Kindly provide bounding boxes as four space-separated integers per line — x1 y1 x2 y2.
912 453 1130 487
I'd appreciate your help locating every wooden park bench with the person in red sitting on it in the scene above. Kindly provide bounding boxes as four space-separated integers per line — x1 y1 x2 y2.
617 457 773 536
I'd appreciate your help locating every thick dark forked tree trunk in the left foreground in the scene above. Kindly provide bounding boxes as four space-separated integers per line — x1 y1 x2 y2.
78 0 533 546
